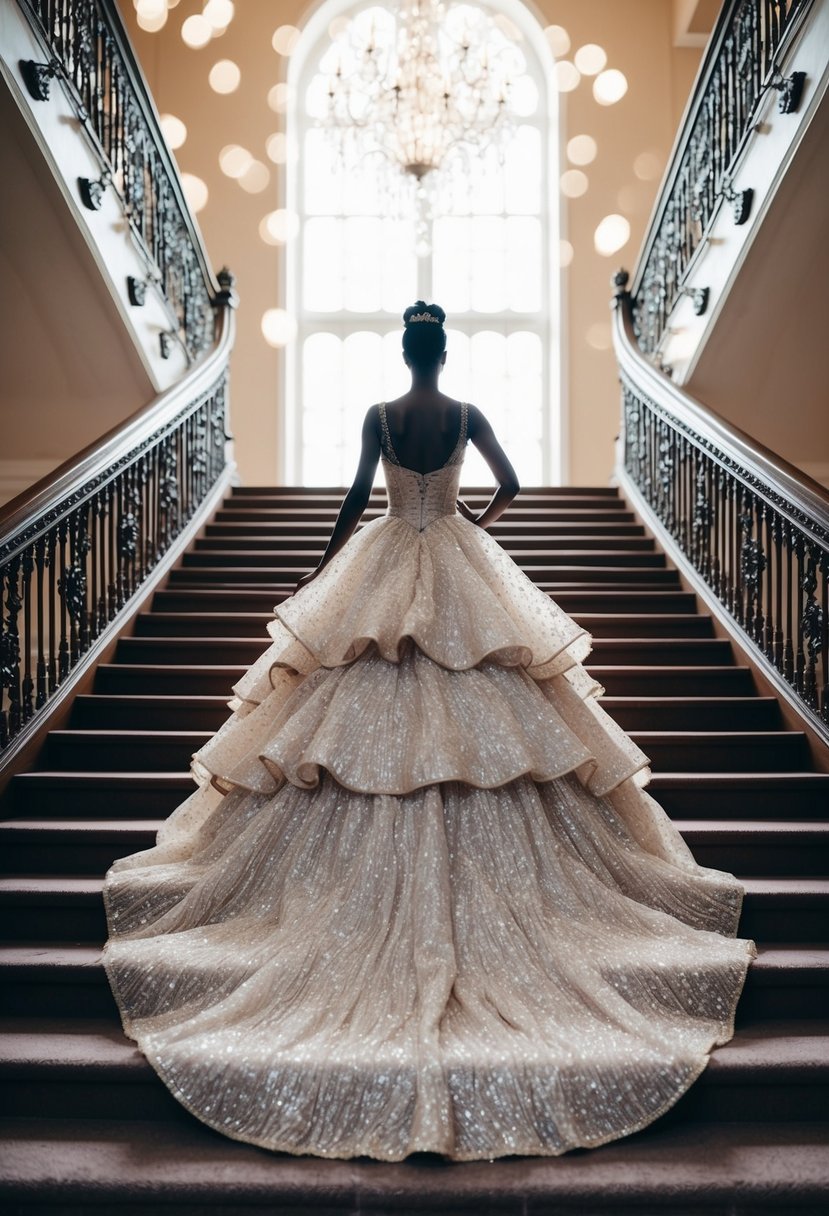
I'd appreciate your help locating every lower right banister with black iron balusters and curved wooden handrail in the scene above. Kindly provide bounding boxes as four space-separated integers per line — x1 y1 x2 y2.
615 284 829 737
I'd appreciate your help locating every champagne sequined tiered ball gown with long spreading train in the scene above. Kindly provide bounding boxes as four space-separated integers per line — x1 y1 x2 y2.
98 409 756 1161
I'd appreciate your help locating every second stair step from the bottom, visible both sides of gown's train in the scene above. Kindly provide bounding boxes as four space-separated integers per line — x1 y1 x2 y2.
0 1017 829 1122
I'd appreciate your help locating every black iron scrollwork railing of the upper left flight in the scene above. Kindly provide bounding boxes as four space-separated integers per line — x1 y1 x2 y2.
18 0 214 361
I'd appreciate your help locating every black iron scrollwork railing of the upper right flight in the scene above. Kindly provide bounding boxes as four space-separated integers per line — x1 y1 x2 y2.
631 0 812 358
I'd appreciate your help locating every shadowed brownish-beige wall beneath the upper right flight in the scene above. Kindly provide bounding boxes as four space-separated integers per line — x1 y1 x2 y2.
687 98 829 484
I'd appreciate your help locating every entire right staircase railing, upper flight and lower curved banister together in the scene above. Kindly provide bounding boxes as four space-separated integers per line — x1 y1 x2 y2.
614 0 829 743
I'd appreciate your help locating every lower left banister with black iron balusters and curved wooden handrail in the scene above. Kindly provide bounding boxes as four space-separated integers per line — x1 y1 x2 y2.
0 342 230 754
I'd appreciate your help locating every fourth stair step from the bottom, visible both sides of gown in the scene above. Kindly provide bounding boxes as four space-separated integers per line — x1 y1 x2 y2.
0 873 829 945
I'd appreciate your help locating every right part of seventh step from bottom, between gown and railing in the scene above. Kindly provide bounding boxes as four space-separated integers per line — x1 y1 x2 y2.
631 730 810 773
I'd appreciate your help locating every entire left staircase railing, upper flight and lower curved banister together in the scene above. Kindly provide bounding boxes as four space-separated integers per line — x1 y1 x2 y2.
0 0 236 764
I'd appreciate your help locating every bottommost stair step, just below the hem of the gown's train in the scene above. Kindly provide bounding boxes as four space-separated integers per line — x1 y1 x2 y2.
0 1119 829 1216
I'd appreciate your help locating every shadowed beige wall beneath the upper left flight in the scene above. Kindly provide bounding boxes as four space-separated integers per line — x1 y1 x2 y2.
0 80 154 499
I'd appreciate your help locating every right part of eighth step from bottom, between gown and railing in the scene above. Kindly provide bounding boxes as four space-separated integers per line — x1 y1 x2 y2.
599 697 780 732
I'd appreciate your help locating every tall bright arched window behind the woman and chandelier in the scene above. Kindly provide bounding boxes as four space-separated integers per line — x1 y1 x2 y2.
284 0 563 485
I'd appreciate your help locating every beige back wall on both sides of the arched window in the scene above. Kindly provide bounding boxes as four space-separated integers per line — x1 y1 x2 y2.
119 0 700 484
